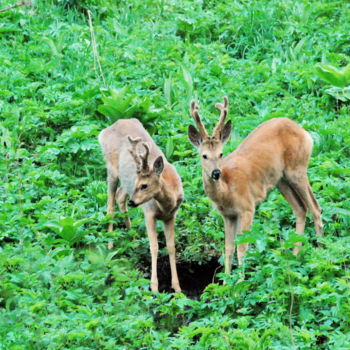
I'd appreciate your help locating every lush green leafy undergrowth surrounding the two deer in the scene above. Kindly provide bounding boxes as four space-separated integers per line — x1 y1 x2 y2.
0 0 350 350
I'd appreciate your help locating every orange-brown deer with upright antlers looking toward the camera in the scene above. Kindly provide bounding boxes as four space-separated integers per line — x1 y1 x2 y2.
188 97 322 273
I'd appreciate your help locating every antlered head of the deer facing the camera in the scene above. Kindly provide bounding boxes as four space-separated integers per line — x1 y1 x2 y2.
188 97 232 181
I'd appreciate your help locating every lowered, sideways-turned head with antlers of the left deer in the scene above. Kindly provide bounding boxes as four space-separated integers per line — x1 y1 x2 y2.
128 136 164 207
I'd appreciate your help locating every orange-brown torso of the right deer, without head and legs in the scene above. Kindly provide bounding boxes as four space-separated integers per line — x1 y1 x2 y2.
216 118 312 204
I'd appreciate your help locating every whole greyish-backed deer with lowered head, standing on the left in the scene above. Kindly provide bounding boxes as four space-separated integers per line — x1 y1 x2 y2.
99 119 183 292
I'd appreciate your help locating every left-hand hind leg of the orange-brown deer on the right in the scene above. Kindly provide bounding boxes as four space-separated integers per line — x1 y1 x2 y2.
277 180 307 255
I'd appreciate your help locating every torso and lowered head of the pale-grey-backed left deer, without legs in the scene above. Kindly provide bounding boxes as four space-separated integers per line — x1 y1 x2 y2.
99 119 183 211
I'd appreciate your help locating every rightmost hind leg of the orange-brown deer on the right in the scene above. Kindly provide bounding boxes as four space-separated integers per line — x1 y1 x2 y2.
286 171 323 247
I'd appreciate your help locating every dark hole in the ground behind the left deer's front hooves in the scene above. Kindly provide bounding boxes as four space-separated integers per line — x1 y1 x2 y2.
140 256 222 298
